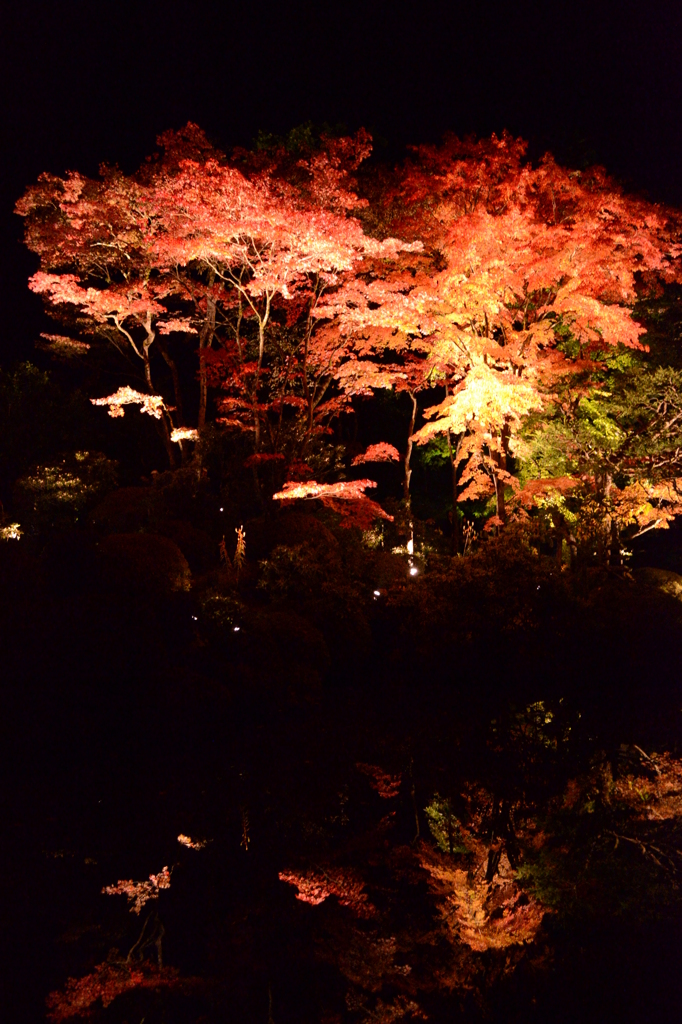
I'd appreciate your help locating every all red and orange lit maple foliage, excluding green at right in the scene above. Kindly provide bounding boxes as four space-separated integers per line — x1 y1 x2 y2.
16 125 682 523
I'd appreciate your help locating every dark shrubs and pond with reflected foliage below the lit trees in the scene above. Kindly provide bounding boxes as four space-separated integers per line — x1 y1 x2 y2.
0 387 682 1022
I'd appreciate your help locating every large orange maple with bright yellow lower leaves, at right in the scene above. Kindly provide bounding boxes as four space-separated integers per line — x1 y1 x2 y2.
327 135 682 524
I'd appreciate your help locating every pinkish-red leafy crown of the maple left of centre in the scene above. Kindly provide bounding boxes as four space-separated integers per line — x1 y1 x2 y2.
151 134 413 299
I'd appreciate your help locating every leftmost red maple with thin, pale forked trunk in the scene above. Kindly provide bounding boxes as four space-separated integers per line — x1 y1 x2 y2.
16 169 186 464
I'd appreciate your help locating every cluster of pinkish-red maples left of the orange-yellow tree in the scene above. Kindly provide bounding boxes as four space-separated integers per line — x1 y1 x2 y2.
16 125 413 475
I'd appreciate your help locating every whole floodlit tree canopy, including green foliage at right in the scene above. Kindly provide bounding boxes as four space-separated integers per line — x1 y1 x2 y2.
16 125 682 559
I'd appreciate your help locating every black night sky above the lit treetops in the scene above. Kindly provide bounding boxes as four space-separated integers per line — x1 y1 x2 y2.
0 0 682 353
